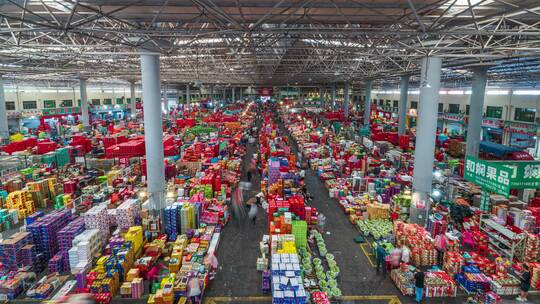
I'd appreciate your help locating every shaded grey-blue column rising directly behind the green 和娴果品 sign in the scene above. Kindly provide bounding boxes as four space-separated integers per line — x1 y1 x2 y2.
466 67 488 157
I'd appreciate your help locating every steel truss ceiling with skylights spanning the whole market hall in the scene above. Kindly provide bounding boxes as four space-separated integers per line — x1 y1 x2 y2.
0 0 540 86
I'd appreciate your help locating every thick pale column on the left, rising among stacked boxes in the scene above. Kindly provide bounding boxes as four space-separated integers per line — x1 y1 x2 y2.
141 53 165 224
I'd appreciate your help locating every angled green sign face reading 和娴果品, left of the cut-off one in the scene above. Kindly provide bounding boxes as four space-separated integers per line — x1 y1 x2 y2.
465 156 512 196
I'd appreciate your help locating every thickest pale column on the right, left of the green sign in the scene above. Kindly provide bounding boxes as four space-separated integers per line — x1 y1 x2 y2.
411 57 442 224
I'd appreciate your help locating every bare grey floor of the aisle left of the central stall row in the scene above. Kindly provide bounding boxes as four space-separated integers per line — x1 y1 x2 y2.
205 119 268 297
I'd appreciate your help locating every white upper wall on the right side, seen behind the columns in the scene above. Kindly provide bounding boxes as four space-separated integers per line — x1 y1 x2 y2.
371 89 540 120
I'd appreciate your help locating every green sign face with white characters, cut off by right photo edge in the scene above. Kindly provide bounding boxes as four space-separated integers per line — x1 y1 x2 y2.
501 161 540 189
